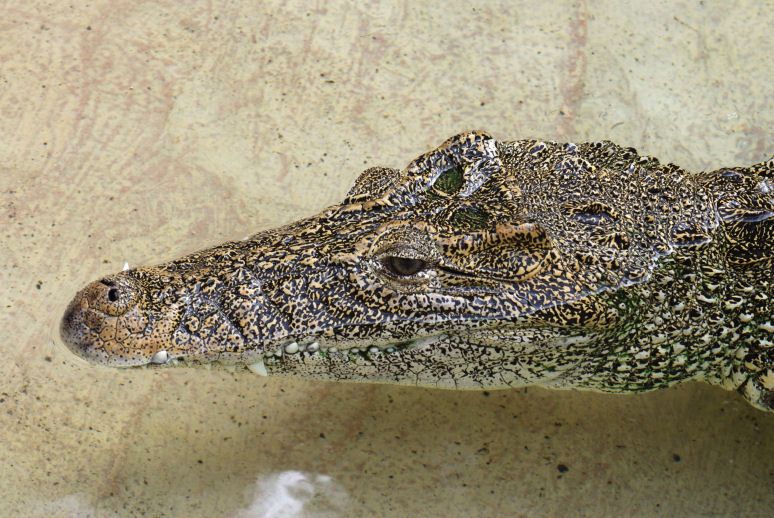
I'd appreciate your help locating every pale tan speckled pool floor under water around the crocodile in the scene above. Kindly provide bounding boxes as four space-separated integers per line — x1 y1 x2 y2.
0 0 774 516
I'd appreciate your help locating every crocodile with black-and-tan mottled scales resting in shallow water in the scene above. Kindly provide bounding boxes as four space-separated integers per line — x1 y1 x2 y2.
60 132 774 411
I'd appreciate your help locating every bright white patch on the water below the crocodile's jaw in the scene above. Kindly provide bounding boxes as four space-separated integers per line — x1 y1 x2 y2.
234 471 348 518
